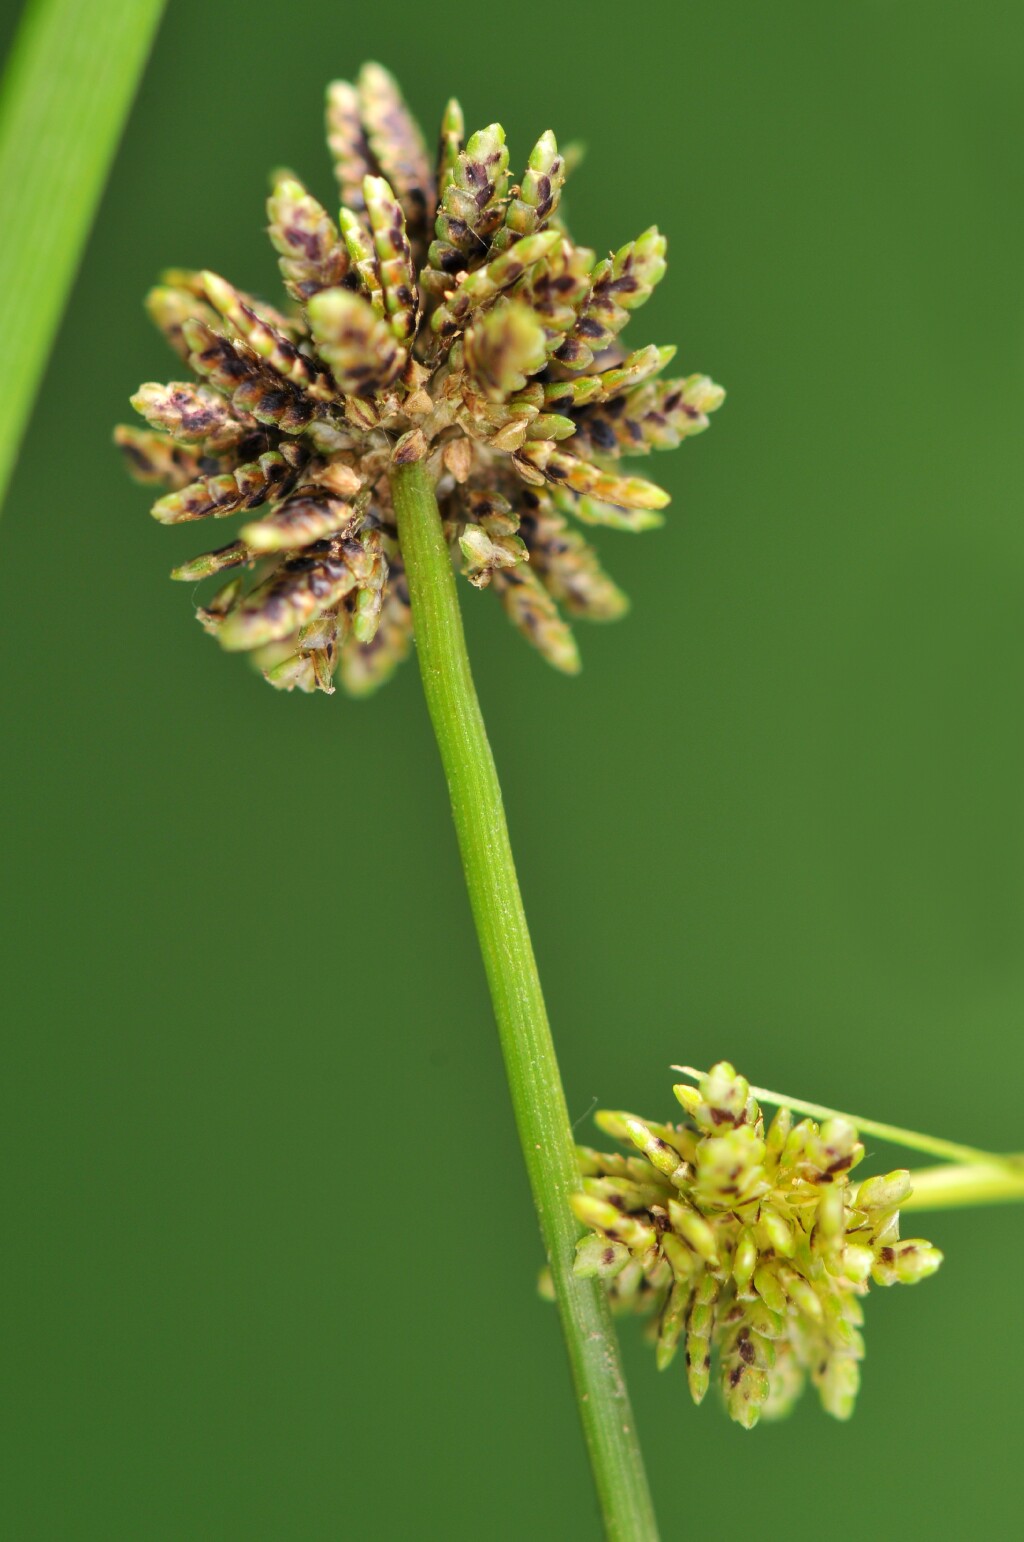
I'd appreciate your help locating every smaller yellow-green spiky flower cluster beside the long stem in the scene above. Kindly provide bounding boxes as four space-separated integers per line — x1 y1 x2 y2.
572 1061 942 1429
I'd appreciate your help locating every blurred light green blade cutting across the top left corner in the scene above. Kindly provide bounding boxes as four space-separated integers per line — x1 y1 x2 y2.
0 0 163 518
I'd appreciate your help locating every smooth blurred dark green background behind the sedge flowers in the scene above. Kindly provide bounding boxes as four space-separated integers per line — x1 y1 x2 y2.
0 0 1024 1542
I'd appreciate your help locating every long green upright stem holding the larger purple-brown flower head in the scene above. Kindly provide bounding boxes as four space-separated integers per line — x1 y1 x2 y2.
392 463 657 1542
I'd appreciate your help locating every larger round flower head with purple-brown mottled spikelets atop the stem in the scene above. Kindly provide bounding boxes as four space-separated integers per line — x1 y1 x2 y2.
116 65 723 694
